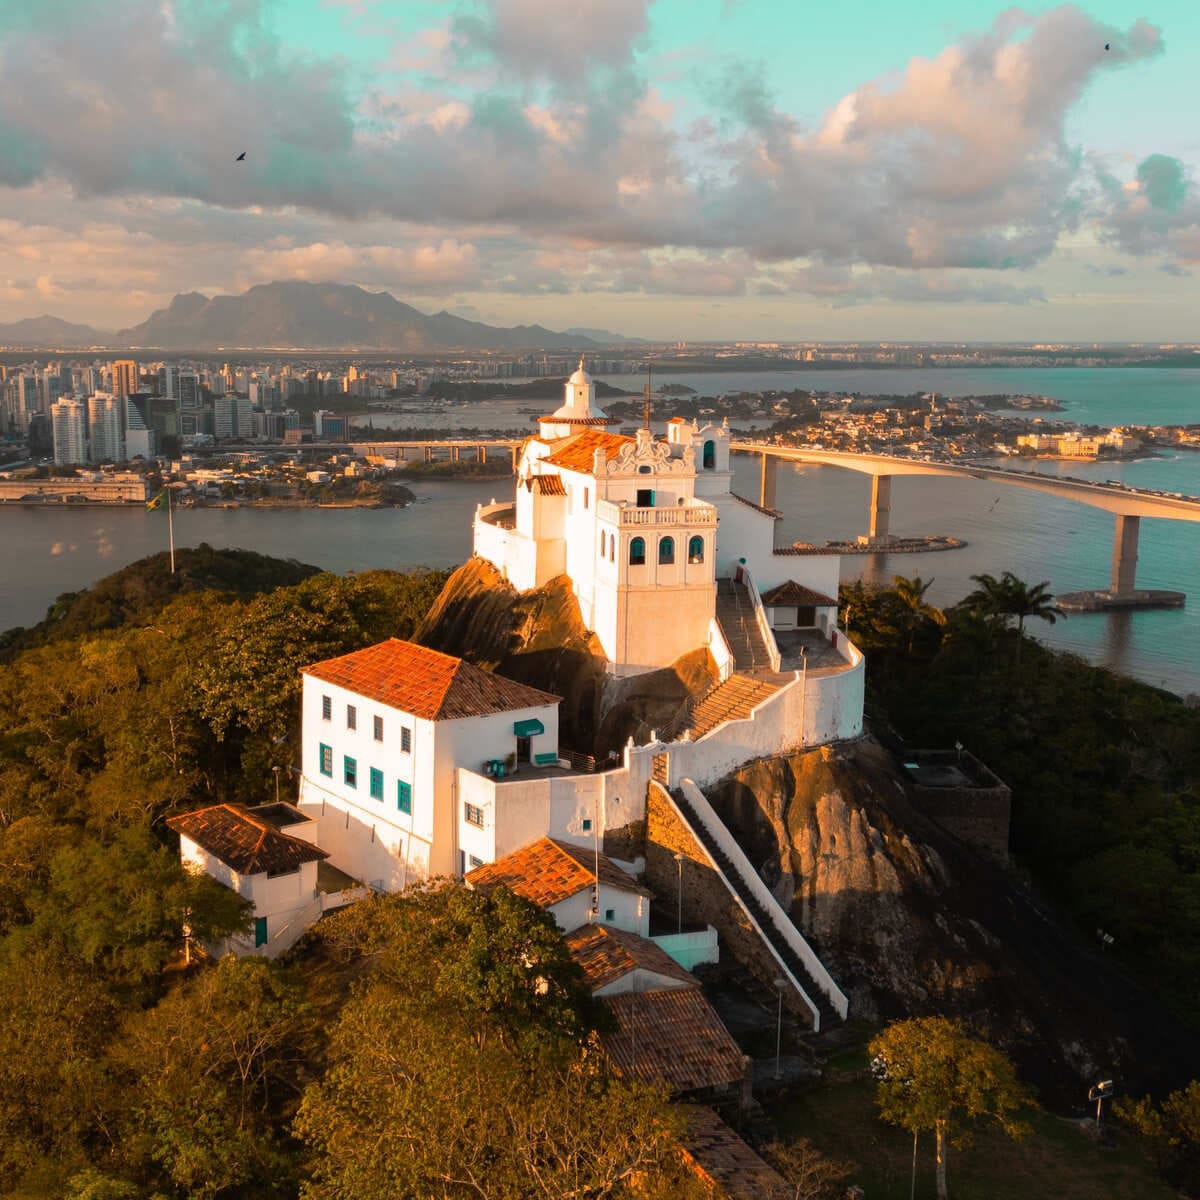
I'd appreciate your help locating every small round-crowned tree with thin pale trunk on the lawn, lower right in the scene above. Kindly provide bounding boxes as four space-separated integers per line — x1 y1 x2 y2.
870 1016 1030 1200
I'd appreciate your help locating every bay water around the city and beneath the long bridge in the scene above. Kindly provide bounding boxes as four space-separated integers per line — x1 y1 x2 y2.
0 368 1200 694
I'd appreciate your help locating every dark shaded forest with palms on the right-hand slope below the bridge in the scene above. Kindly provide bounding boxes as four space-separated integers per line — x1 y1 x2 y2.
841 576 1200 1022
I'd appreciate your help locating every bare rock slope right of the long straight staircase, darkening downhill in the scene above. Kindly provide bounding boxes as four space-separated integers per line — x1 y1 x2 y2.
709 738 1198 1103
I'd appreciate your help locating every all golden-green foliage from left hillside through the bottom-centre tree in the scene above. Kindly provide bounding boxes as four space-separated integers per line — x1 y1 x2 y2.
0 547 696 1200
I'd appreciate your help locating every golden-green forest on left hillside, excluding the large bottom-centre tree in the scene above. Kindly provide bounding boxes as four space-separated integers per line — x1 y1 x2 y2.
0 547 444 1196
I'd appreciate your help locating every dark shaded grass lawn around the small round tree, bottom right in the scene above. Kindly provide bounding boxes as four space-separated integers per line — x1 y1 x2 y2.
772 1062 1176 1200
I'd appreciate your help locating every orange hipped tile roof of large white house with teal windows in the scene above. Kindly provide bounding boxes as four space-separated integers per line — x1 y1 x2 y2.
302 637 562 721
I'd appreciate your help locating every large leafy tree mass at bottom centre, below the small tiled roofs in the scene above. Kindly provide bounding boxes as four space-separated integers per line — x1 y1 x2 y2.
294 883 678 1200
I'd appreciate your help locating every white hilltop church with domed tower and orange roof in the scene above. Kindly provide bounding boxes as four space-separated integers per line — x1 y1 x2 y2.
474 362 839 674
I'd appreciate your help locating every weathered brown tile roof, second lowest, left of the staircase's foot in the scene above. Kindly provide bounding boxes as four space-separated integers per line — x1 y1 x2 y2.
602 988 745 1093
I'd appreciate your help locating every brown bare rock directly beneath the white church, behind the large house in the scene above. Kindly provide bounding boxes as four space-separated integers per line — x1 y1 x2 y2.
416 558 716 758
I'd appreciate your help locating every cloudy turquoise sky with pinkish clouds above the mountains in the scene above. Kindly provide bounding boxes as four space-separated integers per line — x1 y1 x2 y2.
0 0 1200 341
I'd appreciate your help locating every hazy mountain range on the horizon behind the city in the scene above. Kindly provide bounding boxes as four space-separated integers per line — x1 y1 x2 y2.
0 283 643 354
